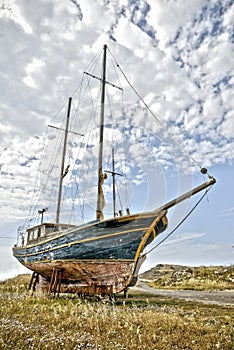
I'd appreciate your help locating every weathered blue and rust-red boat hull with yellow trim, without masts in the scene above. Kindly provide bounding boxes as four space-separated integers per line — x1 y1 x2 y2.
13 211 167 294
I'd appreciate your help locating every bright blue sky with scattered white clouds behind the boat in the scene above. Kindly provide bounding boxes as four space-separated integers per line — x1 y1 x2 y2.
0 0 234 279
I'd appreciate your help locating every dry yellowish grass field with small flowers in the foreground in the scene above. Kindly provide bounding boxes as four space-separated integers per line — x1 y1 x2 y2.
0 275 234 350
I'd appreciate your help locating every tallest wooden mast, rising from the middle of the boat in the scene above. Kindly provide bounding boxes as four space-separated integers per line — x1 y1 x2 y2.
96 45 107 220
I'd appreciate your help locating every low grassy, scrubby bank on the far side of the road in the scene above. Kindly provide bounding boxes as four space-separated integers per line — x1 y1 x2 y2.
141 265 234 290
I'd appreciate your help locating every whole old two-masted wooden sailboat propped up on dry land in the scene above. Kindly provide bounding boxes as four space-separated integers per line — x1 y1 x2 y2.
13 45 215 294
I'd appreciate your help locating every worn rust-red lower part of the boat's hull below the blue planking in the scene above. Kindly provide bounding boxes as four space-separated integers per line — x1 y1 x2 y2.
25 257 144 295
